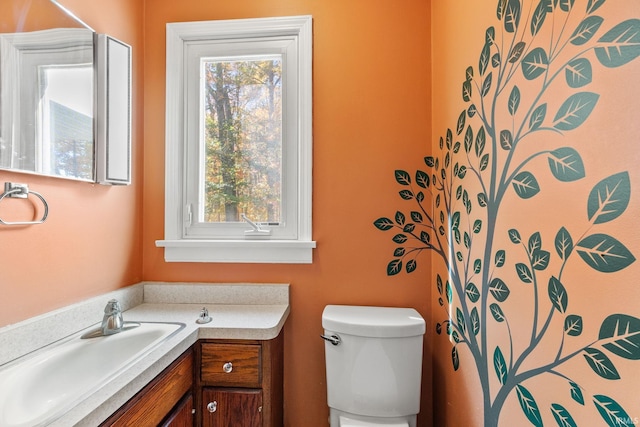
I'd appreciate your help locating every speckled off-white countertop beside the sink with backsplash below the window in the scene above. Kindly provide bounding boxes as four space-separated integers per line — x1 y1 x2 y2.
0 284 289 427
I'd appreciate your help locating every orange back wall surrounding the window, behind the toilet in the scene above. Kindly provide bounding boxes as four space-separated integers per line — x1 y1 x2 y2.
143 0 432 427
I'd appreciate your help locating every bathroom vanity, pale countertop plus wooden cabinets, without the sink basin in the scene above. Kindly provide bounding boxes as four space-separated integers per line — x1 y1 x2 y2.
0 283 289 427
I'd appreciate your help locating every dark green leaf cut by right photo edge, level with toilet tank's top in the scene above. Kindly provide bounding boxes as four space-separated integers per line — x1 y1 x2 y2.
598 314 640 360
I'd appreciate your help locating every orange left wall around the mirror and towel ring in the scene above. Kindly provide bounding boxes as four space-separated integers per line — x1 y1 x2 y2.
0 0 143 326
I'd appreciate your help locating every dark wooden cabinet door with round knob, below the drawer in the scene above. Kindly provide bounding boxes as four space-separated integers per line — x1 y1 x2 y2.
202 388 262 427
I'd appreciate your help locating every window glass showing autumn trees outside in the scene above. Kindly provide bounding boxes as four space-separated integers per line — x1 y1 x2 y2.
199 55 282 223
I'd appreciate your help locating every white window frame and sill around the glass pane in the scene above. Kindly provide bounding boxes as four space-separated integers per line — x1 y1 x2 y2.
156 16 316 263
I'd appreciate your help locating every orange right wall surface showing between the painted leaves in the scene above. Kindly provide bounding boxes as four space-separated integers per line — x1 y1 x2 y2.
430 0 640 427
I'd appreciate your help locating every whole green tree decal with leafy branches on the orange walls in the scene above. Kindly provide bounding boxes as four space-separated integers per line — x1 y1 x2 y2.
374 0 640 426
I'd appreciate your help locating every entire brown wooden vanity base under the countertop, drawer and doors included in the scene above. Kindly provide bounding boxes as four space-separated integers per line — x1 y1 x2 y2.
101 333 284 427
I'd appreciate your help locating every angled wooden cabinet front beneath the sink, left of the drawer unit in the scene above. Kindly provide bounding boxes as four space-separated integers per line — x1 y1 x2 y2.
102 349 195 427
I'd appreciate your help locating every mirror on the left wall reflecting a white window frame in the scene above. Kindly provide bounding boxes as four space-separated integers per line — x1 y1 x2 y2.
0 0 96 181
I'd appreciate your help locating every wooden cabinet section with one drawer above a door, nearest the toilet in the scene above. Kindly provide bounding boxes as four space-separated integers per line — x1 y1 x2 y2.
196 333 284 427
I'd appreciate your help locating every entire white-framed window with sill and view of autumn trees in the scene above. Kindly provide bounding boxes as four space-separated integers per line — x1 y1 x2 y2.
156 16 315 263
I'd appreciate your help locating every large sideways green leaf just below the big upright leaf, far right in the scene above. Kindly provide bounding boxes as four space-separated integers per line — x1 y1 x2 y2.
576 234 636 273
